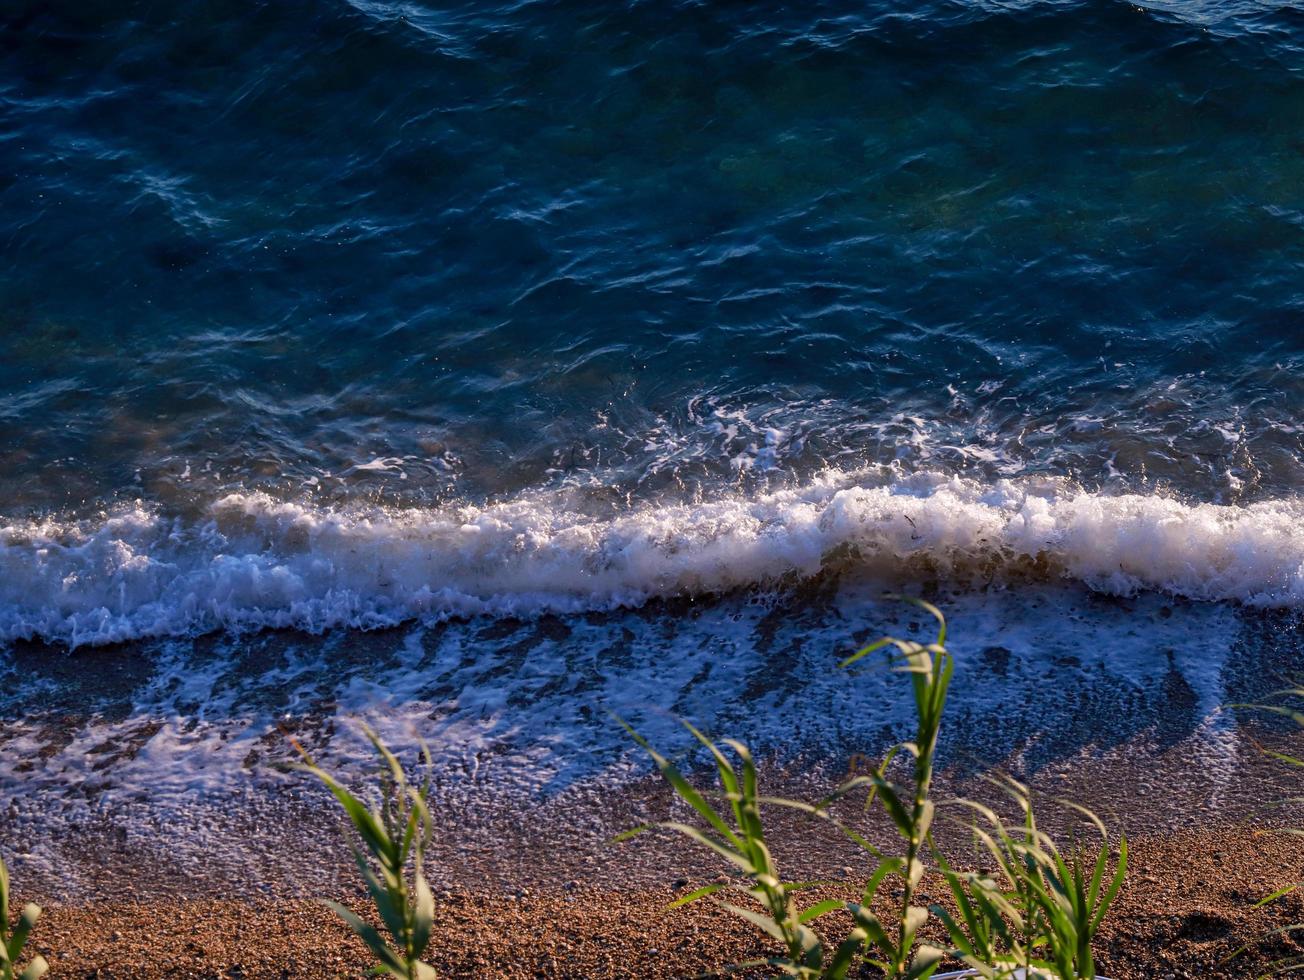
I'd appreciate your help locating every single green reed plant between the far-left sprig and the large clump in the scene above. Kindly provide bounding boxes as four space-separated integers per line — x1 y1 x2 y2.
292 725 436 980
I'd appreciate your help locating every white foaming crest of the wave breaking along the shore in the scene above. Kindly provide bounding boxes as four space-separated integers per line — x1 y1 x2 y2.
0 472 1304 645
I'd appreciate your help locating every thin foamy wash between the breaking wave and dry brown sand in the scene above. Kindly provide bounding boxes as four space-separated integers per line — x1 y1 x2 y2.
0 577 1283 899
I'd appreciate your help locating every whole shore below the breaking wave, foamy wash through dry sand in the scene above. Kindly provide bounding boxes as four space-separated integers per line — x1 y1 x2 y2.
0 593 1304 980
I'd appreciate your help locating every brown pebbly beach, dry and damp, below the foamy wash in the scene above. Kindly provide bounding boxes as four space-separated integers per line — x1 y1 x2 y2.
10 732 1304 980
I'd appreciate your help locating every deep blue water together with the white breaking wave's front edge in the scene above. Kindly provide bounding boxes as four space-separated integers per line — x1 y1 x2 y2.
0 0 1304 642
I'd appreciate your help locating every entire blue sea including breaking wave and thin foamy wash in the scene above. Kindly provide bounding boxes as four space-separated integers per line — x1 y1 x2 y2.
0 0 1304 895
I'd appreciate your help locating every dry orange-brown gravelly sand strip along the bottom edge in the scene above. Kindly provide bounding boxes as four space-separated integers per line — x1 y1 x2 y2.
25 831 1304 980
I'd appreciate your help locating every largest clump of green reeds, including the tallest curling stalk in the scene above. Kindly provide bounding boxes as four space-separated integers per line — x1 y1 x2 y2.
618 599 1127 980
